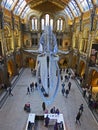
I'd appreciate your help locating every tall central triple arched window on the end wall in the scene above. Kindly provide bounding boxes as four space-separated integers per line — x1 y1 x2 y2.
41 14 53 30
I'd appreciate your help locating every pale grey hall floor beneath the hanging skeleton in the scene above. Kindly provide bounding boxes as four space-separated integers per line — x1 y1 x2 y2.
0 69 98 130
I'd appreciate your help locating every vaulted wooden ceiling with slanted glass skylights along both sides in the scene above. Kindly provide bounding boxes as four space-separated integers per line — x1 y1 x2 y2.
1 0 98 19
